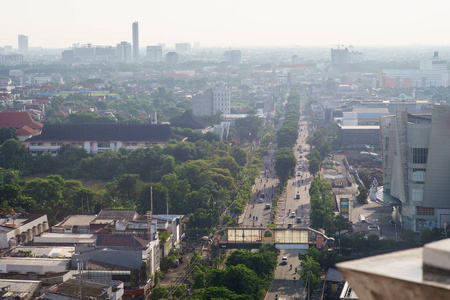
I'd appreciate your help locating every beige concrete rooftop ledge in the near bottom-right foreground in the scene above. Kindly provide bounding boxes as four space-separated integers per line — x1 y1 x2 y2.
336 239 450 300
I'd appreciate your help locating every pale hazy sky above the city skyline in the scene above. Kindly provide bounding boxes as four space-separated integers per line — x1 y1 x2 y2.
0 0 450 48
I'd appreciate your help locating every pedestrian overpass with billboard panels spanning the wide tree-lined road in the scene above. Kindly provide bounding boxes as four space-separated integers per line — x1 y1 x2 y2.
216 227 327 250
